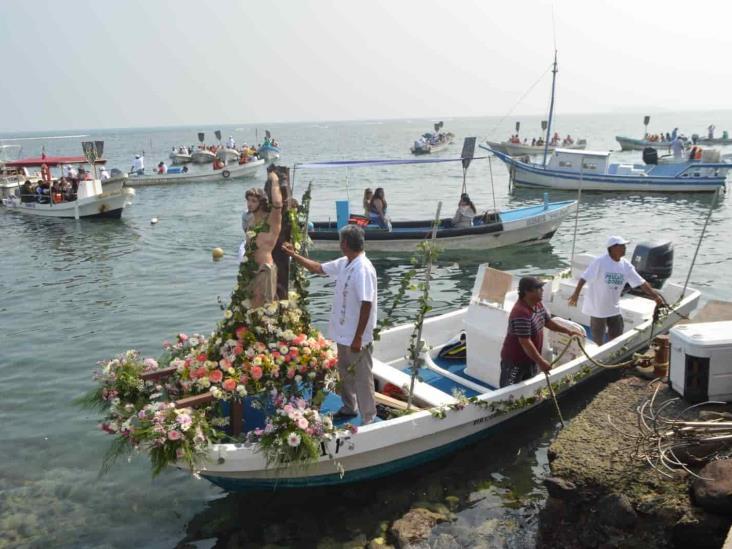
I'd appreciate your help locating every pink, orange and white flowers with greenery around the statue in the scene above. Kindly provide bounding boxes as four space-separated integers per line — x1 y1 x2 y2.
78 188 344 474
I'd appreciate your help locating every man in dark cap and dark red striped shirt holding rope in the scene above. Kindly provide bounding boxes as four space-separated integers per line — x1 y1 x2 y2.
501 276 582 387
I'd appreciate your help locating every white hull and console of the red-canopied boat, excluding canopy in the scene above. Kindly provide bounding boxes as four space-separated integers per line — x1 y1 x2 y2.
2 179 135 219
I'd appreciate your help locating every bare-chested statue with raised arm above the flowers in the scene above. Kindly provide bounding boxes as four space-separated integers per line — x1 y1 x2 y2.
250 171 282 308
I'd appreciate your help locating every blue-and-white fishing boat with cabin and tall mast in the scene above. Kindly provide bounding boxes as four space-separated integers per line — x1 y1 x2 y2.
481 145 732 192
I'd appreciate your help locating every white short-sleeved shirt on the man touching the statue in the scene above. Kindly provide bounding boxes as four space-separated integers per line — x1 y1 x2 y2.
323 254 376 345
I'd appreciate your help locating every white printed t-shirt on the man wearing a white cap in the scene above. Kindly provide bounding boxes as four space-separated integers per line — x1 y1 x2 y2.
582 254 645 318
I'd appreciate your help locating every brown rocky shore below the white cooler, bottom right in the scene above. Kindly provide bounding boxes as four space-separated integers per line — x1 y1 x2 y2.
538 375 732 549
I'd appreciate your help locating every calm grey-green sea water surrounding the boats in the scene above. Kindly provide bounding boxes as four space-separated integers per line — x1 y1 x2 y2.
0 112 732 547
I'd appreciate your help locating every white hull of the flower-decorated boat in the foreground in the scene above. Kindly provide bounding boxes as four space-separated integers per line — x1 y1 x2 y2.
198 285 700 491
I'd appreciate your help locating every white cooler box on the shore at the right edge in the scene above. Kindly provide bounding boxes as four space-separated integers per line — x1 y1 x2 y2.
669 321 732 402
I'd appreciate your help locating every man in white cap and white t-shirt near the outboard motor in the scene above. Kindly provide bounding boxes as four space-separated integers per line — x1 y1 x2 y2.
569 236 663 345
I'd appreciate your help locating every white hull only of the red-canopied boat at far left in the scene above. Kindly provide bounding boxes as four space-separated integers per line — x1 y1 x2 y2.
2 189 134 219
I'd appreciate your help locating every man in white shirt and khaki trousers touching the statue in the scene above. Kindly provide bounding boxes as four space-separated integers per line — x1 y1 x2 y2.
282 225 377 425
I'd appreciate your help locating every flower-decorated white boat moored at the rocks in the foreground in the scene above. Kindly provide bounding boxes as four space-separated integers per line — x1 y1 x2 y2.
87 231 699 491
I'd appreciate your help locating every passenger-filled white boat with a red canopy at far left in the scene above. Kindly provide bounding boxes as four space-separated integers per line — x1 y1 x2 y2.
2 156 135 219
